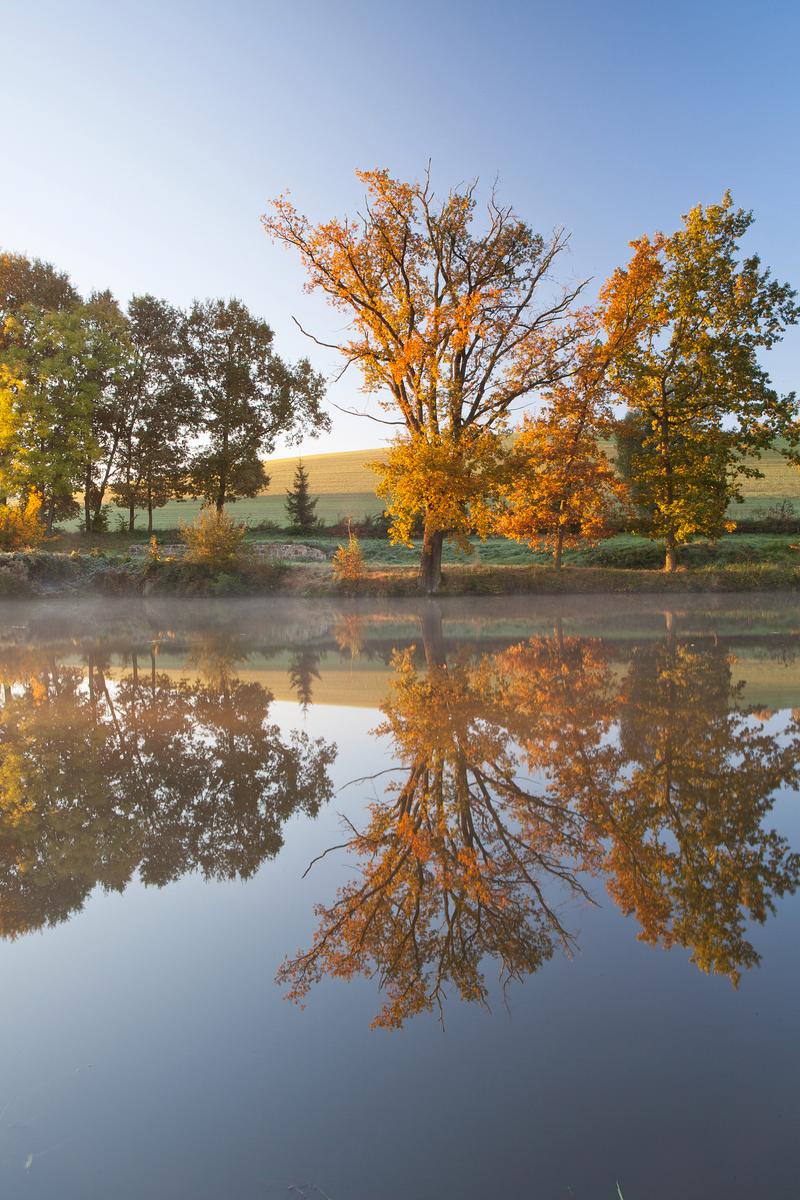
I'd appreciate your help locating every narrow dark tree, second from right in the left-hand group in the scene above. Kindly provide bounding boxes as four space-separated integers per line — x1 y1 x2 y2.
114 295 194 533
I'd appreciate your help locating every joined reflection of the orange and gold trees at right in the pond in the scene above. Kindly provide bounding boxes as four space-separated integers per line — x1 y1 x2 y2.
279 619 800 1025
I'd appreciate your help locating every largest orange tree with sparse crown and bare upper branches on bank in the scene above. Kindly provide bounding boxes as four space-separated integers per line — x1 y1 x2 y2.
263 170 581 593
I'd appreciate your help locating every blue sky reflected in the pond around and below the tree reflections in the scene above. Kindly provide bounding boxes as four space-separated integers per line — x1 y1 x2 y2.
0 600 800 1200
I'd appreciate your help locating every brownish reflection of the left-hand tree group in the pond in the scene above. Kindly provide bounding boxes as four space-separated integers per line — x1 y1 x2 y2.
0 654 333 935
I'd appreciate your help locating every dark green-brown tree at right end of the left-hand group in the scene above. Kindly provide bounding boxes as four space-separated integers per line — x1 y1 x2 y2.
184 300 330 512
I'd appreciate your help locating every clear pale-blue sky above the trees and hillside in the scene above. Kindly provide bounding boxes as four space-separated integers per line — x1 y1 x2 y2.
0 0 800 452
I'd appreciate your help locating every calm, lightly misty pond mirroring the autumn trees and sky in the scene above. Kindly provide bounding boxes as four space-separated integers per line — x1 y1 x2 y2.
0 596 800 1200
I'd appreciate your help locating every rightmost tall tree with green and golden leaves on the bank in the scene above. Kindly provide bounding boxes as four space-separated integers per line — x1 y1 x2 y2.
601 193 800 570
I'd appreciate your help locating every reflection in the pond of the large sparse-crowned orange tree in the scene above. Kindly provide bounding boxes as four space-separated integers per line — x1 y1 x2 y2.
282 653 594 1025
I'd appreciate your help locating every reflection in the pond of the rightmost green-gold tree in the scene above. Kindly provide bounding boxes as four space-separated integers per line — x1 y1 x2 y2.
587 637 800 982
